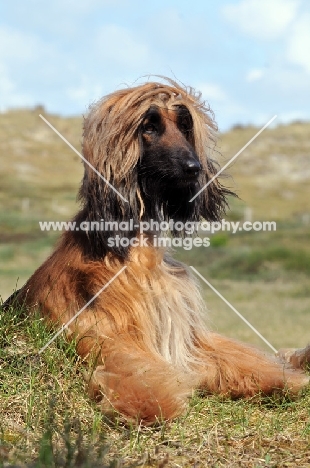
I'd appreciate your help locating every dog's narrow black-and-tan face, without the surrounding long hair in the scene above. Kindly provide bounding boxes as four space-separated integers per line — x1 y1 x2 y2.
138 106 202 208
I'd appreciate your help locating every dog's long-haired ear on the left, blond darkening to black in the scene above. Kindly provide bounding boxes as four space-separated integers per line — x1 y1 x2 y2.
76 109 143 259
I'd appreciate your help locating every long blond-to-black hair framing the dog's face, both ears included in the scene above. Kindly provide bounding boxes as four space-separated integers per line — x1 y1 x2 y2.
76 77 234 258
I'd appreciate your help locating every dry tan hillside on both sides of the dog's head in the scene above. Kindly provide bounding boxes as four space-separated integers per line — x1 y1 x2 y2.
0 110 310 226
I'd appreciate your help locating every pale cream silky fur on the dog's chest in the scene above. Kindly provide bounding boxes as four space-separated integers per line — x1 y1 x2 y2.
128 247 205 369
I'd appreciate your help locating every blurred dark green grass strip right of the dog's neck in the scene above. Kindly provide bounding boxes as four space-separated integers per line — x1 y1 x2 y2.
177 221 310 281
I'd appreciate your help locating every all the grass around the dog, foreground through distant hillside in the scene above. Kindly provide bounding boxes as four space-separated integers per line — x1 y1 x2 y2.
0 110 310 468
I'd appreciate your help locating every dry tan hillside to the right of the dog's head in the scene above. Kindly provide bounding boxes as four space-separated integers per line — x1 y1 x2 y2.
219 122 310 220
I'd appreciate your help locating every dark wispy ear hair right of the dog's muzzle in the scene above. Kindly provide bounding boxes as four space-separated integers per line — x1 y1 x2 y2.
197 159 237 221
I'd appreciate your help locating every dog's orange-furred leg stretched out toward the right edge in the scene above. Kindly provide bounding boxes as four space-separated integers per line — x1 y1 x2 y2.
195 333 309 397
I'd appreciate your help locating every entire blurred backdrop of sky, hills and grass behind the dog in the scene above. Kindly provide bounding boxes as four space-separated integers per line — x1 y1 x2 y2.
0 0 310 347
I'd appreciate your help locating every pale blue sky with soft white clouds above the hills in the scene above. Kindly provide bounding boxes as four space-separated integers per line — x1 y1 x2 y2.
0 0 310 130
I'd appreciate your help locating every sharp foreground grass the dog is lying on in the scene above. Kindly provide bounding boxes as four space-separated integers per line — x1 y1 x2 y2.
0 309 310 468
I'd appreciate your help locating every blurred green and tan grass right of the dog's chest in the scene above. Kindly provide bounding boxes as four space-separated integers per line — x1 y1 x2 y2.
176 222 310 351
